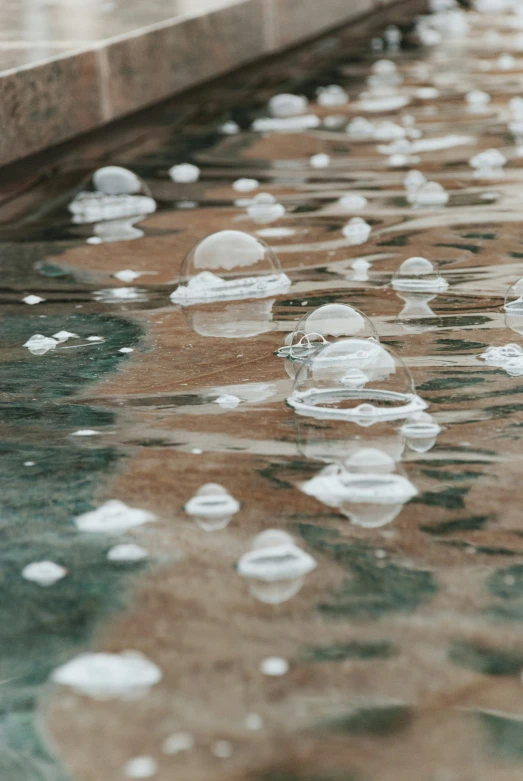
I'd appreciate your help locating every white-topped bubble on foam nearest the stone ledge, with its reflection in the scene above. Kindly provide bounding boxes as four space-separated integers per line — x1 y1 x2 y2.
69 165 156 244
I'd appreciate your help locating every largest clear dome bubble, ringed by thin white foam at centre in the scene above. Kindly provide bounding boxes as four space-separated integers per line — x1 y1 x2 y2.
287 338 426 425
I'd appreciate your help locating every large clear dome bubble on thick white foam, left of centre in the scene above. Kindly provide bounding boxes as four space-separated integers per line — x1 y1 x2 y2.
171 230 291 306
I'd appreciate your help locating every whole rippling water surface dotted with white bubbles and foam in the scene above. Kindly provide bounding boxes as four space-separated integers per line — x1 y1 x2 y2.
7 0 523 781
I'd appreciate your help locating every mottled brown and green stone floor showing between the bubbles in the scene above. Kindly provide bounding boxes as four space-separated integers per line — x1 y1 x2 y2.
5 1 523 781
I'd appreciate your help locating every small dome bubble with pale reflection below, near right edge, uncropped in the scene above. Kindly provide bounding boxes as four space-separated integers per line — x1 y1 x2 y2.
391 257 449 320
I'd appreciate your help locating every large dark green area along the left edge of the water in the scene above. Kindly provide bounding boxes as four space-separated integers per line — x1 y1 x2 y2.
0 314 141 781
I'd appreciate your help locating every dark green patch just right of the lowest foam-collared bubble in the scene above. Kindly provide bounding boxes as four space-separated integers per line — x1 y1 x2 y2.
297 524 437 619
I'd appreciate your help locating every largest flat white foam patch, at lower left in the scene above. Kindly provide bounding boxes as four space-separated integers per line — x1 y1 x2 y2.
51 651 162 700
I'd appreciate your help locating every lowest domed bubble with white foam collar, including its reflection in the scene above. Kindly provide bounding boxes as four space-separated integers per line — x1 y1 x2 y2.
238 529 316 605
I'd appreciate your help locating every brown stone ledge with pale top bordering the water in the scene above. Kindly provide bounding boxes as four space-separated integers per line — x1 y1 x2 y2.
0 0 410 164
